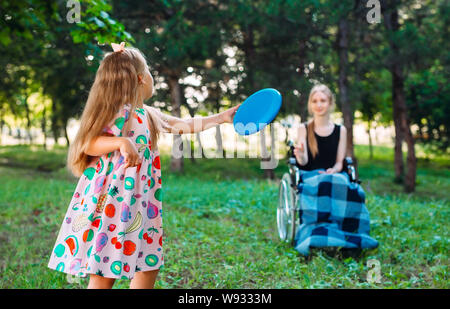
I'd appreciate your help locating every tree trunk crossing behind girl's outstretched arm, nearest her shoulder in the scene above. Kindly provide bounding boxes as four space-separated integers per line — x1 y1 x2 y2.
168 75 183 172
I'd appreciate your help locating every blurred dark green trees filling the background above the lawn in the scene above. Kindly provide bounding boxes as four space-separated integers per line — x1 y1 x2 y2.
0 0 450 192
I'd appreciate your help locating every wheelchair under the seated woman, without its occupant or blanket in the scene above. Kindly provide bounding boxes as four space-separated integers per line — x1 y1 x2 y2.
277 140 361 246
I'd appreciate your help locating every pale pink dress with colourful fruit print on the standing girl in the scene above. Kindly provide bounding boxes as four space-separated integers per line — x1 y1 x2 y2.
48 104 164 279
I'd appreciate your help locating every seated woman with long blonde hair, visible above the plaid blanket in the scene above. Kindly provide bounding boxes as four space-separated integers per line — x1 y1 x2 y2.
294 84 347 174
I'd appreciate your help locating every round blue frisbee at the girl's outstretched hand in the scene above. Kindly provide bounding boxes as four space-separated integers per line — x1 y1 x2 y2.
233 88 281 135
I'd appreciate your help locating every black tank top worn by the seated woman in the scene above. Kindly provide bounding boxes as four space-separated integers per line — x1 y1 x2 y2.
297 124 341 171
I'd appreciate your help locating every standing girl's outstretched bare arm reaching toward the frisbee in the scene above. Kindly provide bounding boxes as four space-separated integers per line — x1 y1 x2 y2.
144 104 241 134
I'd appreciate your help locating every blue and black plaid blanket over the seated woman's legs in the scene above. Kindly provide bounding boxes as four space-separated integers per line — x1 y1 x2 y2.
295 170 378 255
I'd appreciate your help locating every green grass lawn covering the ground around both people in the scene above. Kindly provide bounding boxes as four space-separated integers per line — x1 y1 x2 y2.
0 146 450 288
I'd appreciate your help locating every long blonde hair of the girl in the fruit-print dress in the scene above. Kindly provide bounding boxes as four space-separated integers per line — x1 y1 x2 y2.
67 47 170 177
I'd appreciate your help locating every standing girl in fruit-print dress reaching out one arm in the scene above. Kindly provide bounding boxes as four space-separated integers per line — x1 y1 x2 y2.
48 42 239 288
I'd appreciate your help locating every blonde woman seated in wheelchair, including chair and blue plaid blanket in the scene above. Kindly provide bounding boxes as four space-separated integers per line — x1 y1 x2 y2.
277 84 378 256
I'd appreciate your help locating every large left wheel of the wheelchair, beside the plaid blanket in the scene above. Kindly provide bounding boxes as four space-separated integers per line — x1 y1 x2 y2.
277 173 296 244
